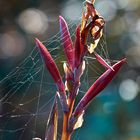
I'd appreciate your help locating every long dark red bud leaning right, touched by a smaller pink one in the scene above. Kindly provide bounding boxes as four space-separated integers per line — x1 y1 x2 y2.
74 59 126 117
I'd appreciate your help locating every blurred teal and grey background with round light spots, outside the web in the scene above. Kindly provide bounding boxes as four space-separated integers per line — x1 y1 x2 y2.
0 0 140 140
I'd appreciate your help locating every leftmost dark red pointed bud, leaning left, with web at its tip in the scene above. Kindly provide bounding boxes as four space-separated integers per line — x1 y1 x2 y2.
36 39 65 92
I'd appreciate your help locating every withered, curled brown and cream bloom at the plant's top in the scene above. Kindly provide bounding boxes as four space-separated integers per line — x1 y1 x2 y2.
81 0 105 53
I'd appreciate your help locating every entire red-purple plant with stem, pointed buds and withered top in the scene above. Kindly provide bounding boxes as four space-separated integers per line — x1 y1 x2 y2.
36 1 125 140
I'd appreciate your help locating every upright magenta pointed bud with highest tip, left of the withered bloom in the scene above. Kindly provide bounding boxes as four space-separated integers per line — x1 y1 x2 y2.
59 16 74 69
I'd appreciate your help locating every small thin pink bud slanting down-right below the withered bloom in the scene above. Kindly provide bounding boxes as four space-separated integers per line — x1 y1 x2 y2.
94 52 114 71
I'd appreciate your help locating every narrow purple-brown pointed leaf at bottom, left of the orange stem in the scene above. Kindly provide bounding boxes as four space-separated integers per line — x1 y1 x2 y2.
45 98 58 140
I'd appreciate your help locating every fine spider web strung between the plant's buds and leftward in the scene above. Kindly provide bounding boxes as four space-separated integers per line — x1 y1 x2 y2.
0 15 115 140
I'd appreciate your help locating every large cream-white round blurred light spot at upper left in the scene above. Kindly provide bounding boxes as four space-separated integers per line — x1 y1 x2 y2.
18 8 48 34
